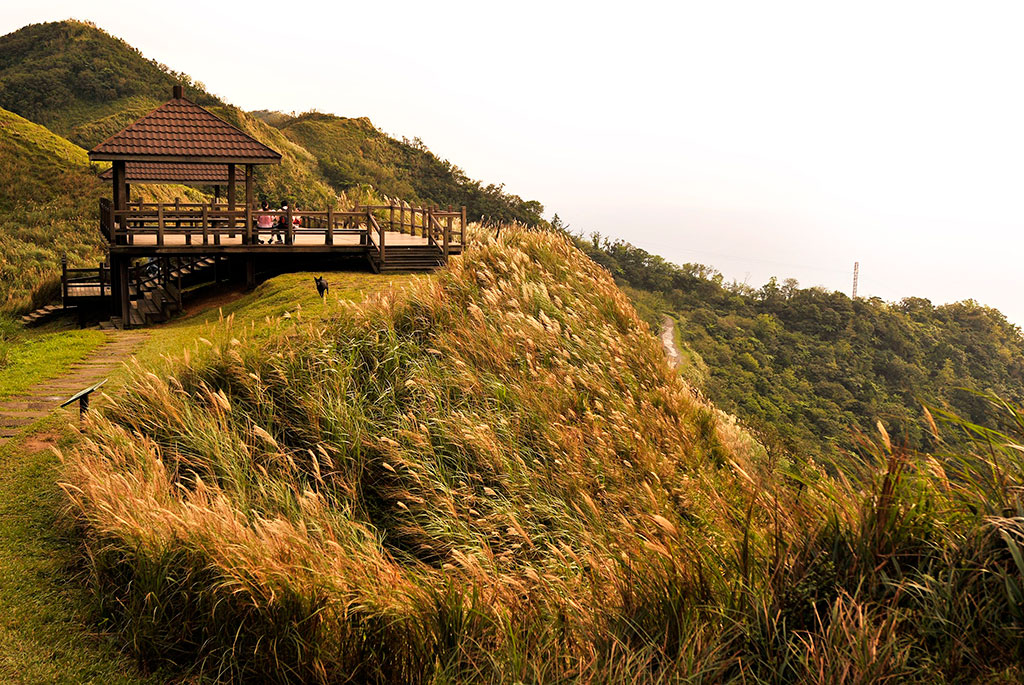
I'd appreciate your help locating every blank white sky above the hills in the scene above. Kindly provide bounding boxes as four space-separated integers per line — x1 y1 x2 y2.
6 0 1024 324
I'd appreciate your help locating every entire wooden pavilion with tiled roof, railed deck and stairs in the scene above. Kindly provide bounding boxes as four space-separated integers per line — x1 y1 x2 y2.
72 86 466 328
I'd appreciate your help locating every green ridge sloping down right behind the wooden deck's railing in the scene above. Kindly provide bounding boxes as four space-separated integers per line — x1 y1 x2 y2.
272 113 544 225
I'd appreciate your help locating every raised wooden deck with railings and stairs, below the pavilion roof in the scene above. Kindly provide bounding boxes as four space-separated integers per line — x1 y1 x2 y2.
61 199 466 327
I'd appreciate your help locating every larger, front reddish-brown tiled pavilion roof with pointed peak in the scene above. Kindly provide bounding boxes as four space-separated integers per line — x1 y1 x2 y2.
89 93 281 164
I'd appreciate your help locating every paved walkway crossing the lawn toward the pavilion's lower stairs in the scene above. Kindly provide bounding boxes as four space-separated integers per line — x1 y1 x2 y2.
0 331 146 444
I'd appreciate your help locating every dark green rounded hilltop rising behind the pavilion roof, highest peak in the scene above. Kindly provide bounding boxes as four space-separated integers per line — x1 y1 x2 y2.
0 19 218 143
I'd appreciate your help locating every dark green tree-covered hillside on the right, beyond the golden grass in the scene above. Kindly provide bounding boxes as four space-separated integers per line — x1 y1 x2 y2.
581 235 1024 457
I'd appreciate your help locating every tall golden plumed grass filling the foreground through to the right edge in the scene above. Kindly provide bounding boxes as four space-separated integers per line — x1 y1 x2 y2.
63 229 1024 683
